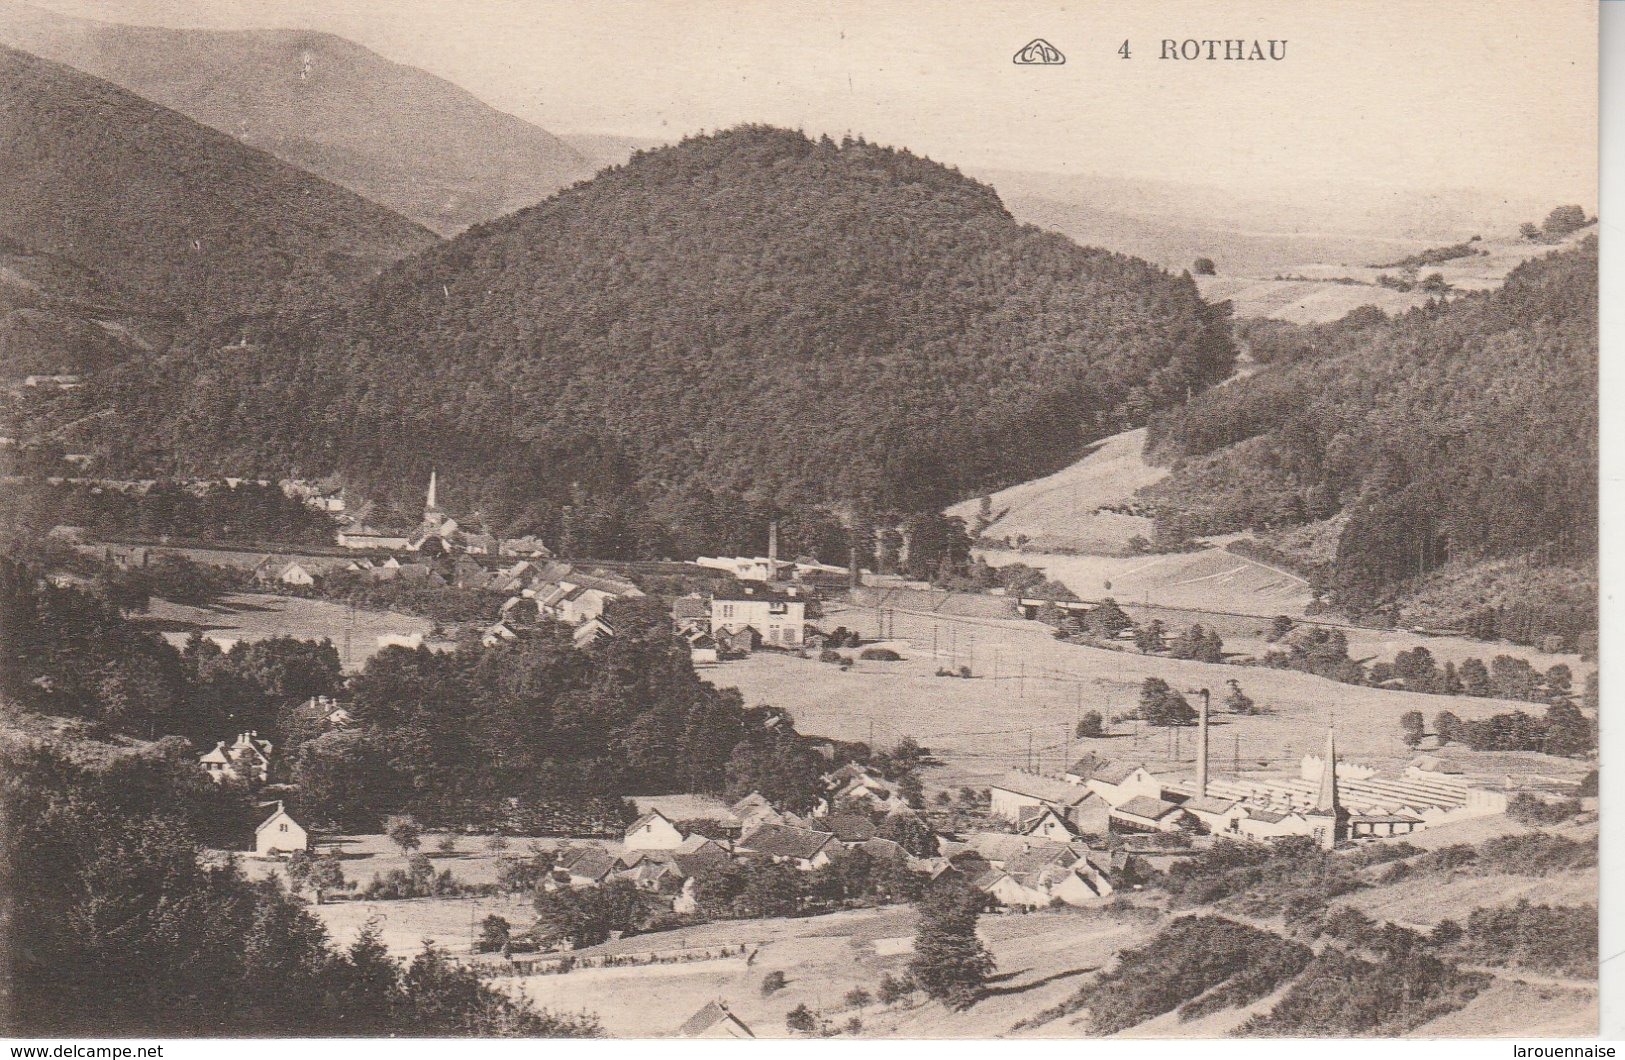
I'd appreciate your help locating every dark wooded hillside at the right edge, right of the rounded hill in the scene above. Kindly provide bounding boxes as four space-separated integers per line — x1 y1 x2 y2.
1149 237 1597 632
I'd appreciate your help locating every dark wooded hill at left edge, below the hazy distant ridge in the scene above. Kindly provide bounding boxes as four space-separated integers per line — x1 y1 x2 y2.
0 47 436 319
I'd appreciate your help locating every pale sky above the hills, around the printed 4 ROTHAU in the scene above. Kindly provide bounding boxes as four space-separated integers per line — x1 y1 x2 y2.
25 0 1597 205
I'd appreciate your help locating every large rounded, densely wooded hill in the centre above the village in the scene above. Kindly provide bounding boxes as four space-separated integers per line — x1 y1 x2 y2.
98 127 1233 554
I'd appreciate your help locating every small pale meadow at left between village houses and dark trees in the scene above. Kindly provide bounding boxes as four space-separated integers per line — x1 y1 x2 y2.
137 592 434 671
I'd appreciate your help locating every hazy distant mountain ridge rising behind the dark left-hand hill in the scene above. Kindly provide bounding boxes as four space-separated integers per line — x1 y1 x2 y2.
0 0 592 236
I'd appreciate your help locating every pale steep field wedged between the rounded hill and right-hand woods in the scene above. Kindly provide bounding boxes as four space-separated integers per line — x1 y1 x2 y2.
947 428 1168 554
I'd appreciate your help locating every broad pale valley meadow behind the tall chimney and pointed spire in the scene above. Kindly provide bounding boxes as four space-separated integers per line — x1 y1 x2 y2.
707 608 1528 787
